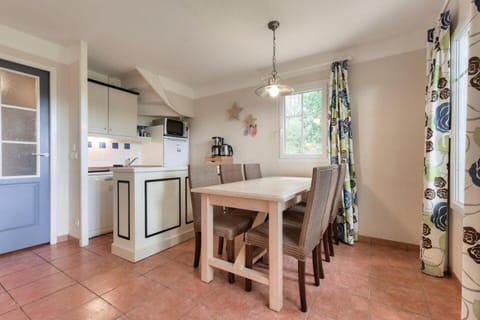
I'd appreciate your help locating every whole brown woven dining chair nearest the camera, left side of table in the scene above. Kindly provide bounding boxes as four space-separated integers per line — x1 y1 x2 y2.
188 165 254 283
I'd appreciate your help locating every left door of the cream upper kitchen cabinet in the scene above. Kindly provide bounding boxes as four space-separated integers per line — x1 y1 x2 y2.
88 82 108 134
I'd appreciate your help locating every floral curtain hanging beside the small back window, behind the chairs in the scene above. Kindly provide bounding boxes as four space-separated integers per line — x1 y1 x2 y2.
328 60 358 244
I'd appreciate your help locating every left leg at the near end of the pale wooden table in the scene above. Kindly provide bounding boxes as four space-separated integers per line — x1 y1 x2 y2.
200 193 213 282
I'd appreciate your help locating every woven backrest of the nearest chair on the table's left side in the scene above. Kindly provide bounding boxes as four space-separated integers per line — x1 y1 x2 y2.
188 165 223 231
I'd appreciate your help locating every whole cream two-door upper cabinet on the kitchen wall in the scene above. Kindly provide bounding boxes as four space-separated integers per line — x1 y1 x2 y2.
88 80 138 137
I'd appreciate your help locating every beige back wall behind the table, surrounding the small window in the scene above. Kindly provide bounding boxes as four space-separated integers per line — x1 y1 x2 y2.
191 50 425 244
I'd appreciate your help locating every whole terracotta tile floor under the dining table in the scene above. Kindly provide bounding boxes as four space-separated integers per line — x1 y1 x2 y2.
0 234 461 320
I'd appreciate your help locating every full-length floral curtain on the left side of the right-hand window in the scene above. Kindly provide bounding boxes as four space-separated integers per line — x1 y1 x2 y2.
421 11 450 277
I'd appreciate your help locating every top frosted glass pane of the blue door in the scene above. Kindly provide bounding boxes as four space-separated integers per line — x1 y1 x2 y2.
0 70 37 109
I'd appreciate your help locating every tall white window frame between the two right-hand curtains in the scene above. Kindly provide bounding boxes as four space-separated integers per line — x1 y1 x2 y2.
450 25 469 212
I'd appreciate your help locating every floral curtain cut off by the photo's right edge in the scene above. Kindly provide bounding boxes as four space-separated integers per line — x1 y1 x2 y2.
462 0 480 319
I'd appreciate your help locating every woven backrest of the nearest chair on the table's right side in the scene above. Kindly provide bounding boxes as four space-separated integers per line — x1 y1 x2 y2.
298 166 338 252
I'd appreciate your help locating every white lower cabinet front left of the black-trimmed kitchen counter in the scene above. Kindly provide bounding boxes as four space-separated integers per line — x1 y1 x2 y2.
88 173 113 238
